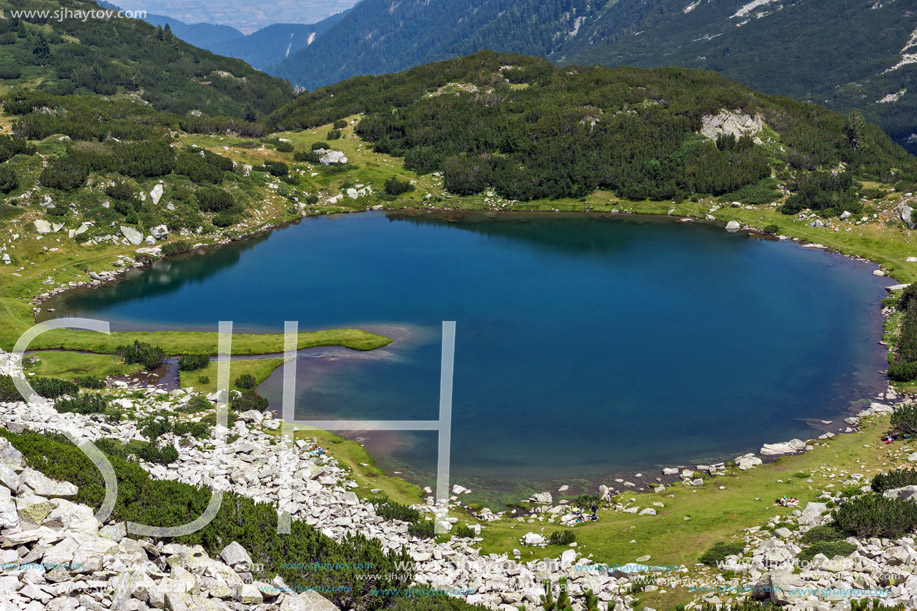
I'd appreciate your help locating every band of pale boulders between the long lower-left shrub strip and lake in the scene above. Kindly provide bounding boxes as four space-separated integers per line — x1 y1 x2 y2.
0 368 631 609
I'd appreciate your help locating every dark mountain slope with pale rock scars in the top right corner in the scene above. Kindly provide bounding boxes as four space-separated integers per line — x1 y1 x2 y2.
554 0 917 152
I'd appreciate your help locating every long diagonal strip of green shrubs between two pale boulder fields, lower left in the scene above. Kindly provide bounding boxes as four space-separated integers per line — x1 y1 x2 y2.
0 430 428 611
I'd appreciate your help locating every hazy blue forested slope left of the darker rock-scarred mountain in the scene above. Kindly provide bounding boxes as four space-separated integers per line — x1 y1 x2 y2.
269 0 608 89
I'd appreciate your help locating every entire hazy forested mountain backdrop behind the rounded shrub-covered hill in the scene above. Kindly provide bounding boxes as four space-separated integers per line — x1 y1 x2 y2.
269 0 917 151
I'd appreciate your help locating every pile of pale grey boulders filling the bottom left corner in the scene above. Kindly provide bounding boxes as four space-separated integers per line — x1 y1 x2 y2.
0 438 337 611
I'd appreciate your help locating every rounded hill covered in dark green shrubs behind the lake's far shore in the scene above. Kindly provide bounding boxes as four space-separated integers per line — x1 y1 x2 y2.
269 52 917 204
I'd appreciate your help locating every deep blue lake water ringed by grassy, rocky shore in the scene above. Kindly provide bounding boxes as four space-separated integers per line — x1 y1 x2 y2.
48 213 889 500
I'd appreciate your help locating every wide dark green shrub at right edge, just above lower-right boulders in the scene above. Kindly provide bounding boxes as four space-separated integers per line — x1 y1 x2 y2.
834 494 917 539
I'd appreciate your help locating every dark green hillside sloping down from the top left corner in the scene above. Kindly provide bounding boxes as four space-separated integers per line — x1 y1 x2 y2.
0 0 293 119
